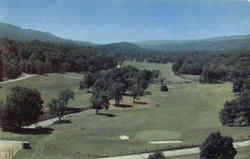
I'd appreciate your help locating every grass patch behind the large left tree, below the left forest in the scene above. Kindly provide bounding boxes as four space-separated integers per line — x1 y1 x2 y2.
0 73 90 107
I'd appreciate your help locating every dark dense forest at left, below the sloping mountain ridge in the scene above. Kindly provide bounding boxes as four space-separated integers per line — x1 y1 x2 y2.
0 39 118 79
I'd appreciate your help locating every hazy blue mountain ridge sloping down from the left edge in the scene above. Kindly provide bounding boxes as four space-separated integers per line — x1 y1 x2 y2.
0 23 94 46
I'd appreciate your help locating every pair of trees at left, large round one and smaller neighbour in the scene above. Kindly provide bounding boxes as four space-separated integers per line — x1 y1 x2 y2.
0 86 74 131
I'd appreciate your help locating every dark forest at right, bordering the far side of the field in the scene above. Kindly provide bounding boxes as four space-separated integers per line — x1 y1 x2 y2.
172 51 250 83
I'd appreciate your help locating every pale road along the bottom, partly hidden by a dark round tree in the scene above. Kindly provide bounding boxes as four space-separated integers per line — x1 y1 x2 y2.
101 141 250 159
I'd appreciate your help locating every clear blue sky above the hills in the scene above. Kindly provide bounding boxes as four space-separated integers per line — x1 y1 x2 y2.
0 0 250 43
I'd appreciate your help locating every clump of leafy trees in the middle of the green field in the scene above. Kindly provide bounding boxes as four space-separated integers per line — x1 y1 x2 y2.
80 66 159 113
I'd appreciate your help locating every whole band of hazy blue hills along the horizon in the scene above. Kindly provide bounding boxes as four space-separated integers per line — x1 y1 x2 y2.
0 23 250 54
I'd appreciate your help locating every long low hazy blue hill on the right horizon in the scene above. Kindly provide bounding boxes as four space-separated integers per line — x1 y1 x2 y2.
135 35 250 52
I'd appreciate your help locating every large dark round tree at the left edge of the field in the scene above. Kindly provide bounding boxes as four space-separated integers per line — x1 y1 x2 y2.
1 87 43 130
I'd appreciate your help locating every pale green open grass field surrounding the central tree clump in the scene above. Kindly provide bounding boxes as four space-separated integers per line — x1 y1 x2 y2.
1 62 250 159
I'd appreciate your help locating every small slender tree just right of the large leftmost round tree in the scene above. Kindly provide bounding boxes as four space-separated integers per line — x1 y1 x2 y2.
48 89 74 120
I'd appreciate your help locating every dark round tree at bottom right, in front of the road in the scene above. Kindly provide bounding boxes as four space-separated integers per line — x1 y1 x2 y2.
200 132 237 159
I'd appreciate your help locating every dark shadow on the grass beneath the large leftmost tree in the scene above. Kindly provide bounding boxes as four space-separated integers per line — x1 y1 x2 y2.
13 127 54 135
